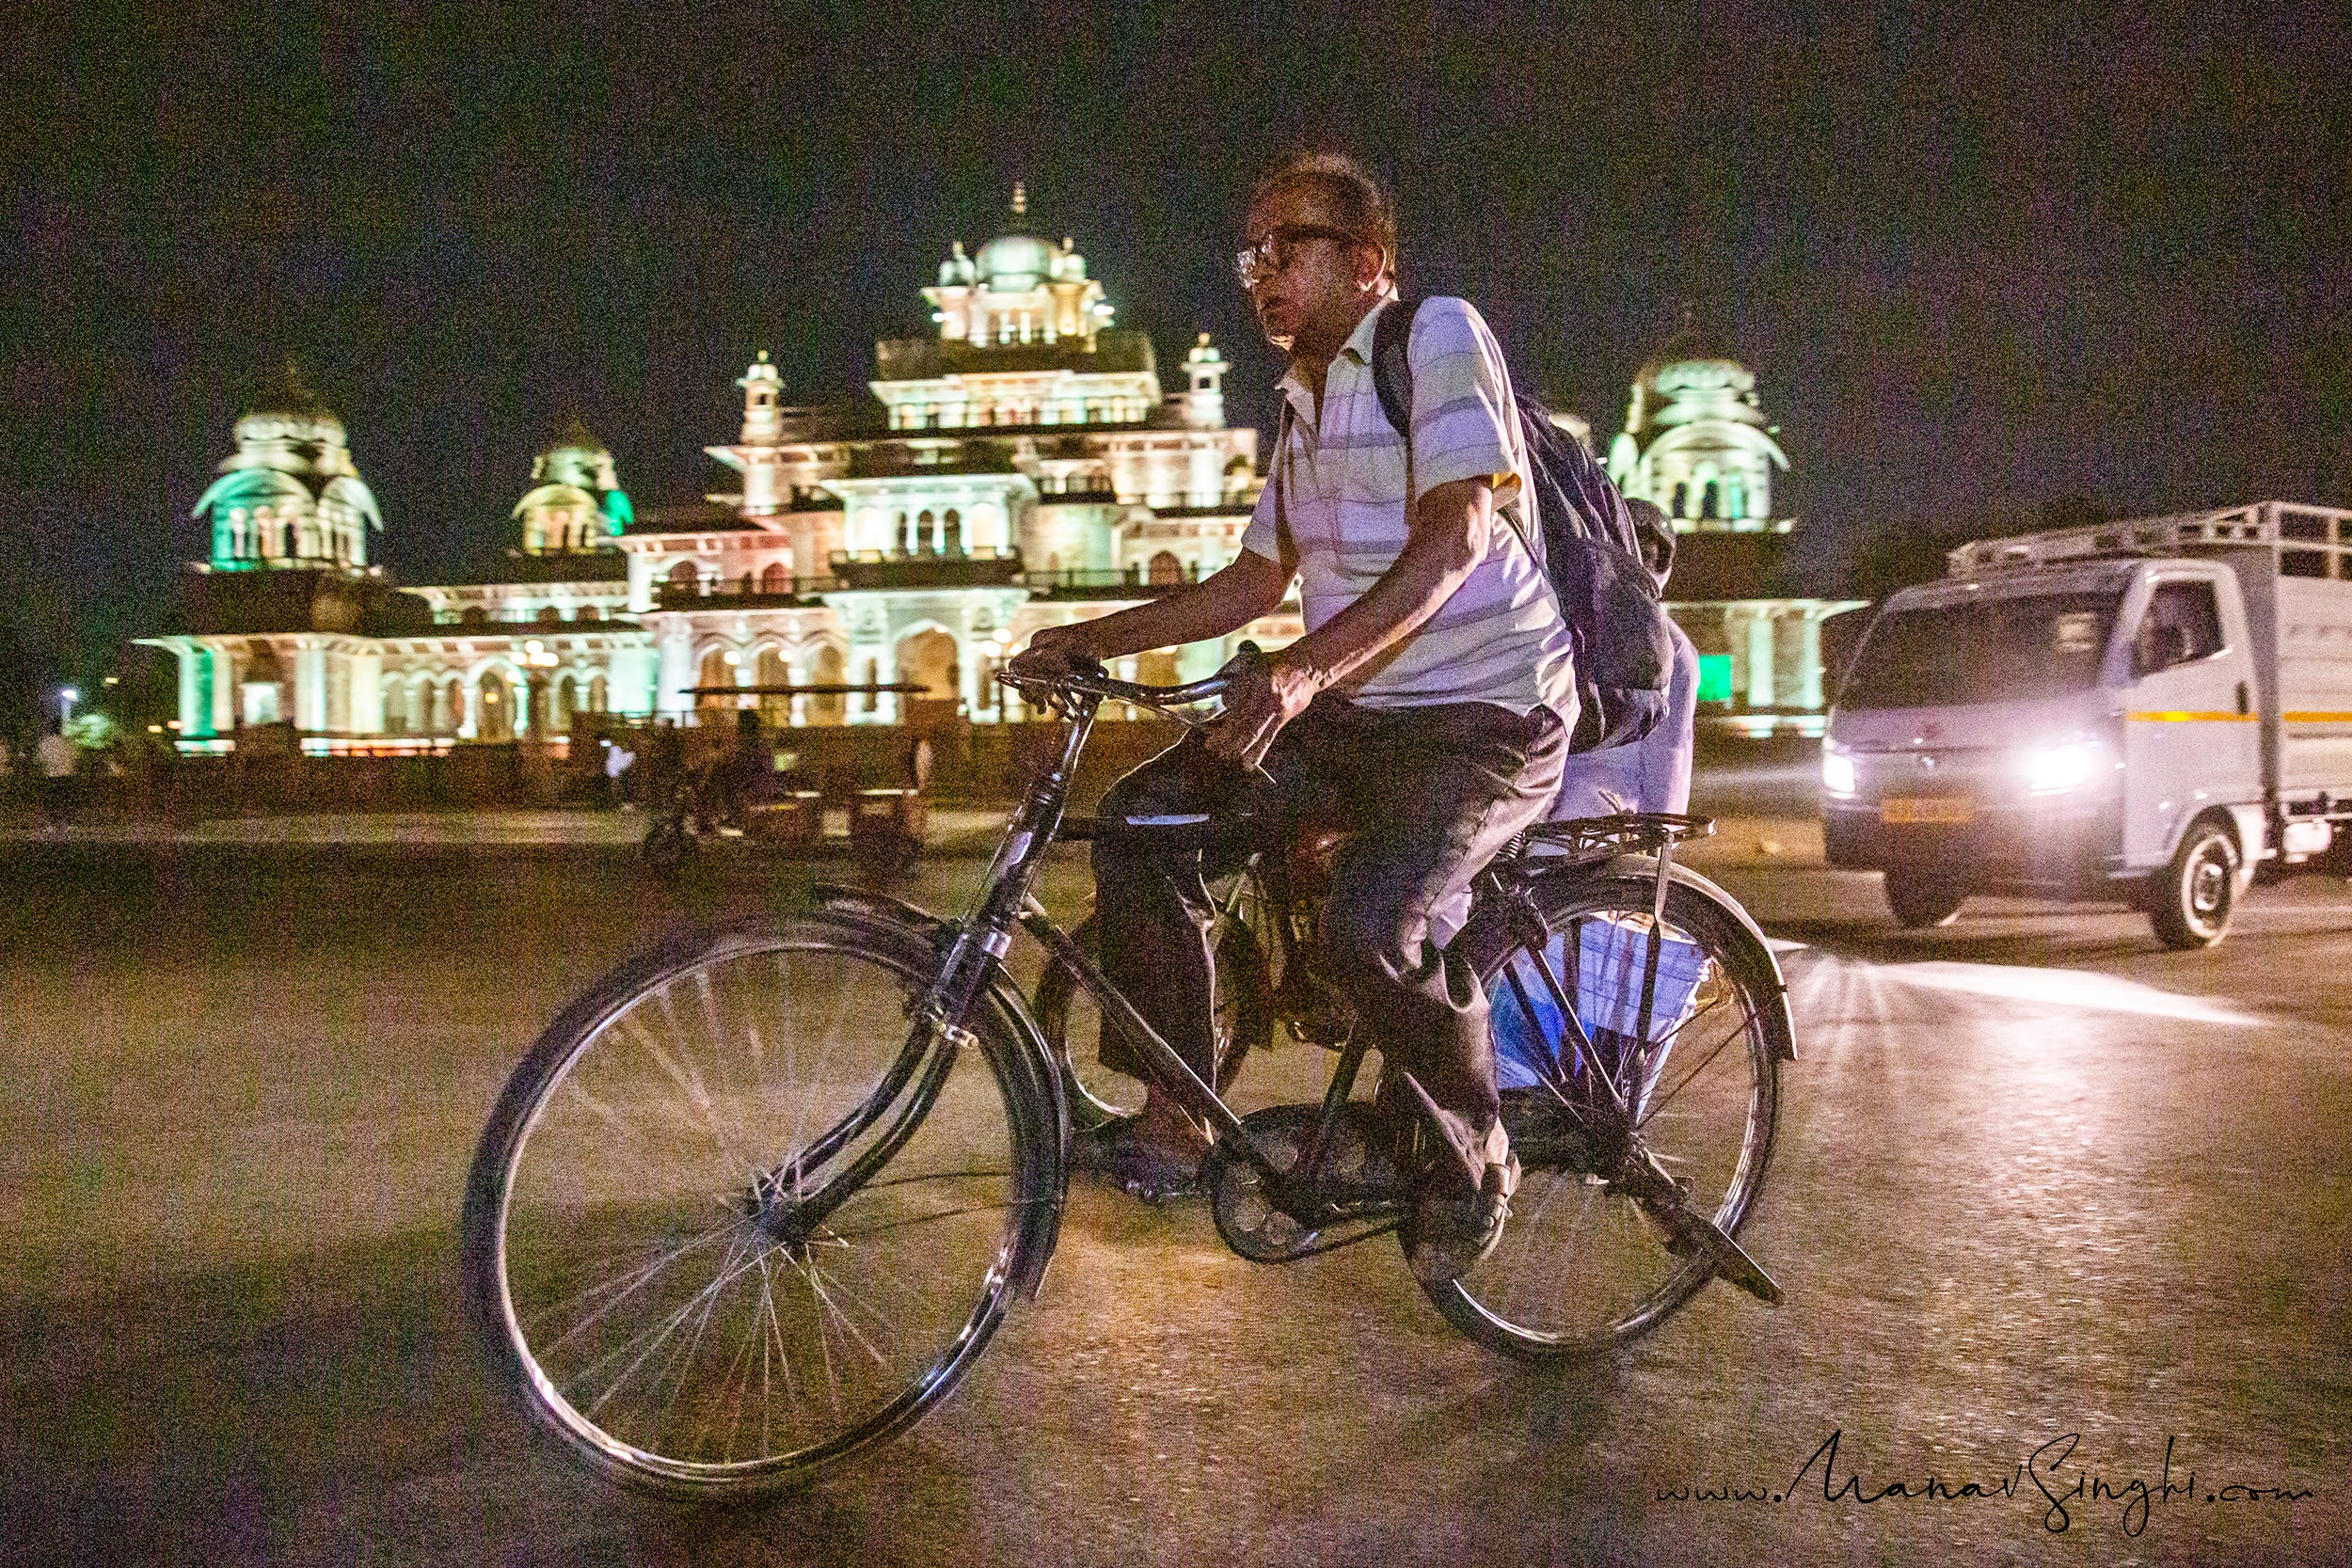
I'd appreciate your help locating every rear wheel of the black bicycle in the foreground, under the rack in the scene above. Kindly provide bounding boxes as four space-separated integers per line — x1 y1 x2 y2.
1423 872 1790 1361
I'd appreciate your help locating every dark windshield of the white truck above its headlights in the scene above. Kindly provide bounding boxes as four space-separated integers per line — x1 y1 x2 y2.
1837 593 2115 707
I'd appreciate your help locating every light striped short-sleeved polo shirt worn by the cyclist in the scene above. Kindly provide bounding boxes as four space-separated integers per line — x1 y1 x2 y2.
1242 298 1576 726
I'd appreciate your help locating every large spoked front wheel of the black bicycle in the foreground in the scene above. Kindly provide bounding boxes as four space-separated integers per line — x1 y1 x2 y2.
464 917 1058 1500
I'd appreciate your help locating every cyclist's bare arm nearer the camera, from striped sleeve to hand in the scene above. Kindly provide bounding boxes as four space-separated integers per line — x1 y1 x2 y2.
1209 480 1494 764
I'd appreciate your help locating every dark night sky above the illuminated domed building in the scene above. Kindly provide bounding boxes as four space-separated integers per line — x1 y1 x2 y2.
0 0 2352 681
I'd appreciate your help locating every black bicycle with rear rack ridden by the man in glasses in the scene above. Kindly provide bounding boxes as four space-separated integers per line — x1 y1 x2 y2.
461 657 1795 1500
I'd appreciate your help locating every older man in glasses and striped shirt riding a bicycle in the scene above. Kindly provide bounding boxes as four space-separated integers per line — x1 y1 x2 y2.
1014 152 1576 1279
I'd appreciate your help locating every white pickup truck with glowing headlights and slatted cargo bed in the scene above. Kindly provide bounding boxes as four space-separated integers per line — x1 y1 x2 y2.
1820 500 2352 947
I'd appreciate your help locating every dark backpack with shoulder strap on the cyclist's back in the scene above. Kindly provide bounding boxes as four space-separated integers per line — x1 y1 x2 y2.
1372 298 1675 752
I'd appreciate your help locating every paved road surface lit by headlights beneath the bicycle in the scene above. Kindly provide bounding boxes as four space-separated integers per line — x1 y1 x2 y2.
0 823 2352 1566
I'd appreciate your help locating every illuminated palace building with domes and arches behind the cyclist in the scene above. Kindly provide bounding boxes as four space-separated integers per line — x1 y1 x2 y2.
149 185 1835 752
